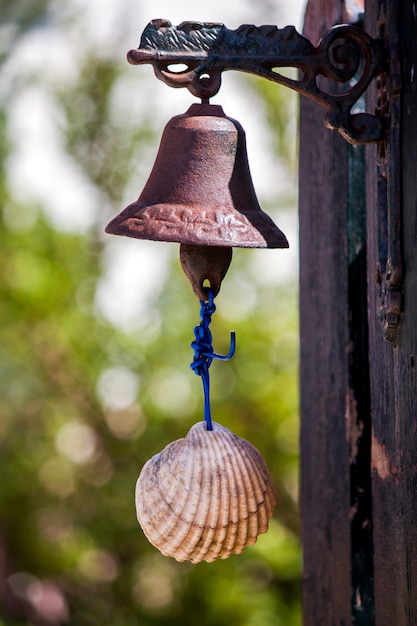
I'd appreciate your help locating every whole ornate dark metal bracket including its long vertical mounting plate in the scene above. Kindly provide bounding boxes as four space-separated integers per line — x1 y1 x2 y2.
124 18 403 345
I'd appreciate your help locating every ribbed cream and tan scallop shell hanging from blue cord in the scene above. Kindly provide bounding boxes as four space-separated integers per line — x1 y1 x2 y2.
136 422 275 563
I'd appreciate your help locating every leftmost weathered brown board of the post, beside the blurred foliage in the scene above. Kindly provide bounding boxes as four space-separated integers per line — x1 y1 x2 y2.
299 1 351 626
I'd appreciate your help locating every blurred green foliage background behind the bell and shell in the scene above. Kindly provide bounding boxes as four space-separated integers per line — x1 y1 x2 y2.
0 1 301 626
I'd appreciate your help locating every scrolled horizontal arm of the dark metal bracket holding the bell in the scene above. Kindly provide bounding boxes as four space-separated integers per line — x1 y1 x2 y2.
128 19 386 144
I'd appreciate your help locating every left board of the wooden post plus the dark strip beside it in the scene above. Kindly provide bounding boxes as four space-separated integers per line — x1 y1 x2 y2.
299 0 374 626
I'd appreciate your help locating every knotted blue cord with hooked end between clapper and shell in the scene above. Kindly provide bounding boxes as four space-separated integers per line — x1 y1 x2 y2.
190 289 236 430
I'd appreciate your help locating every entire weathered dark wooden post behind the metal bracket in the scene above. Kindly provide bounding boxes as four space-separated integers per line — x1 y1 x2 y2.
300 0 417 626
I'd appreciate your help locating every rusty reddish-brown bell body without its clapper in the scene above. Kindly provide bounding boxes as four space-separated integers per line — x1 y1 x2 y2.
106 104 288 248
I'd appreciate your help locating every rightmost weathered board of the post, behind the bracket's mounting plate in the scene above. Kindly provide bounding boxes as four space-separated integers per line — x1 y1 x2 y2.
366 0 417 626
